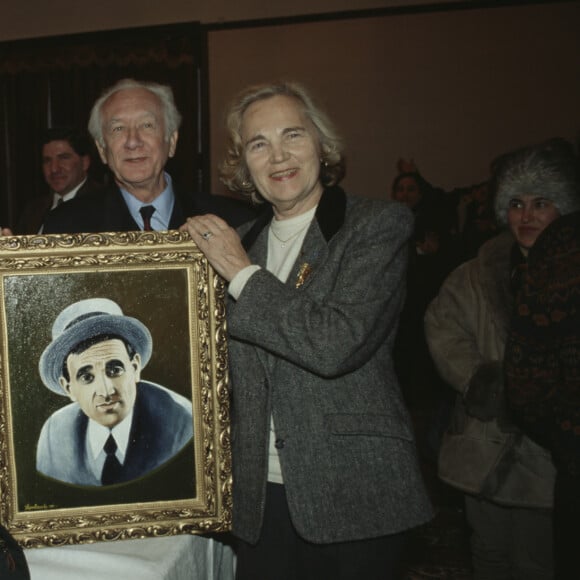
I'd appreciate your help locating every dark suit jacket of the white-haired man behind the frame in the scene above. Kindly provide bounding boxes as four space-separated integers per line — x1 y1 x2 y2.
44 186 255 234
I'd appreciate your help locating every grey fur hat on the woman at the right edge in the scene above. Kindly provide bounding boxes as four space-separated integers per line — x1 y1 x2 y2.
492 138 580 224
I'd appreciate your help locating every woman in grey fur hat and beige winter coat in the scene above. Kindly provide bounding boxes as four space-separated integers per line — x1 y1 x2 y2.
425 139 580 580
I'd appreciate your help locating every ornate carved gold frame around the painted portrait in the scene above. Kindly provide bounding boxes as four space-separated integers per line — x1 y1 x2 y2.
0 231 232 547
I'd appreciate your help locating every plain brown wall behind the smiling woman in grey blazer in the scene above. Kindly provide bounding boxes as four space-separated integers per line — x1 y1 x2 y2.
209 2 580 197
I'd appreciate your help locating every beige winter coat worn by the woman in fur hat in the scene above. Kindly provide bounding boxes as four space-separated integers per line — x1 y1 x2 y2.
425 232 555 507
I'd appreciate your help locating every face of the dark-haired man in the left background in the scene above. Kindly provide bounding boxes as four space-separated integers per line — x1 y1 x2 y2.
42 141 90 195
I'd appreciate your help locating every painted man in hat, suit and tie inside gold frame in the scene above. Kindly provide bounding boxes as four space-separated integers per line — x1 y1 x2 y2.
36 298 193 485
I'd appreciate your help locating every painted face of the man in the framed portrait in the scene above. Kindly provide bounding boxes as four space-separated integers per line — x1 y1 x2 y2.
60 339 141 428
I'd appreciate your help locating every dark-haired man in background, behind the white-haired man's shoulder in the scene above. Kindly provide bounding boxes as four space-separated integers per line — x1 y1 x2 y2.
14 127 102 234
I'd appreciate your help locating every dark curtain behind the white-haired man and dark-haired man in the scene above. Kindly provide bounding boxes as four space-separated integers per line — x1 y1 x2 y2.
0 23 207 226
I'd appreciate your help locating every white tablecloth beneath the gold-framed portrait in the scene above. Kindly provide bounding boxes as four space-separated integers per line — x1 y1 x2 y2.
24 535 234 580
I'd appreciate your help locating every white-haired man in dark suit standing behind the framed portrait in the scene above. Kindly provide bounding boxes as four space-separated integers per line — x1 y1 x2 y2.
44 79 254 233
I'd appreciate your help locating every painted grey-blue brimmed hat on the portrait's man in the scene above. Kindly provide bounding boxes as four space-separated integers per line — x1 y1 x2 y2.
38 298 153 395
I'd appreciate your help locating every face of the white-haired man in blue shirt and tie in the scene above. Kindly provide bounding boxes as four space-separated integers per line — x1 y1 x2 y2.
97 88 177 202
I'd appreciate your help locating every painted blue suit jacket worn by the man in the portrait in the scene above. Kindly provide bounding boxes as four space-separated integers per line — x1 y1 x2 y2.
36 381 193 485
